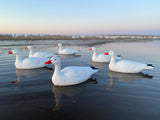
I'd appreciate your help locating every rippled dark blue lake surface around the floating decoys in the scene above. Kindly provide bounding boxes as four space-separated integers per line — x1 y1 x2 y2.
0 40 160 120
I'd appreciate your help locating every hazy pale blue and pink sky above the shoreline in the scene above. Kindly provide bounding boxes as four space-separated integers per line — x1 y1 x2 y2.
0 0 160 34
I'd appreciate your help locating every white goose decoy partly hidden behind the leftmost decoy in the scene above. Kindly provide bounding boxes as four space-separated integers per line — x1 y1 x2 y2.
25 46 55 58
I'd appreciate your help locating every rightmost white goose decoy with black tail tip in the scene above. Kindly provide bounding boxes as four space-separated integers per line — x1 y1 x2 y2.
105 51 154 73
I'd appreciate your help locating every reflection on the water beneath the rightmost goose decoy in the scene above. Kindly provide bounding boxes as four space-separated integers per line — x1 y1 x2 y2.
107 71 153 90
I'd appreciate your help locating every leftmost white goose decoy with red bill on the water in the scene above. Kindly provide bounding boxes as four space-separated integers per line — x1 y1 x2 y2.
8 49 49 69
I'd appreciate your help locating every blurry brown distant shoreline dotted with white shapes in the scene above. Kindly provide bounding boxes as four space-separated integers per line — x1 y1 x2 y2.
0 34 160 41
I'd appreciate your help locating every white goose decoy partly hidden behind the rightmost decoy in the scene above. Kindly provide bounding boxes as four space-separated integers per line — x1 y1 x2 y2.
89 47 121 63
